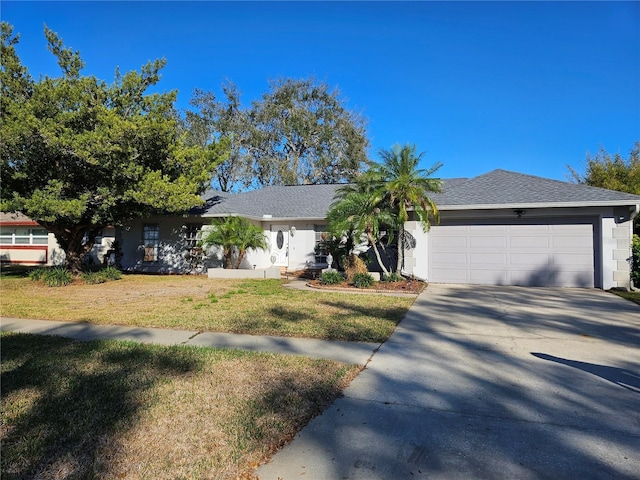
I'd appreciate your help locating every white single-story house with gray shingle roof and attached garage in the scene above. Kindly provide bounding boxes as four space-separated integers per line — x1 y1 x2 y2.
116 170 640 289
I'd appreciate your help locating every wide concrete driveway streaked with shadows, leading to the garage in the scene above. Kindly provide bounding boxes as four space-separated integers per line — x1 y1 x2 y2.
256 285 640 480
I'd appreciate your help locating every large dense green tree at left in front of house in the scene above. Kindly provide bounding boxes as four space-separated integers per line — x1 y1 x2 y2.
0 22 228 271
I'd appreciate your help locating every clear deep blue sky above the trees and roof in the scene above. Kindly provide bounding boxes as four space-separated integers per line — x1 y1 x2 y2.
0 0 640 180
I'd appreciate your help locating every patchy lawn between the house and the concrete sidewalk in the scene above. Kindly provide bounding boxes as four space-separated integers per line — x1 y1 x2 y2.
0 275 414 342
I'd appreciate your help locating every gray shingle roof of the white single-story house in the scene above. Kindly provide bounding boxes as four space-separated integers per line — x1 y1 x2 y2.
199 170 640 219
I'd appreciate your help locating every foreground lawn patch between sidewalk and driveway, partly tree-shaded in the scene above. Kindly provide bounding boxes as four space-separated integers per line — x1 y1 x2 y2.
0 333 359 480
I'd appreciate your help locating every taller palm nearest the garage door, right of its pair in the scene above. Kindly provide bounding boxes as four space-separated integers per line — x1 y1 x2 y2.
371 145 442 273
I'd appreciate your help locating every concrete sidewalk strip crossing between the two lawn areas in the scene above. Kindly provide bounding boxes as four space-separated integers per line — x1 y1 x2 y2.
0 317 380 365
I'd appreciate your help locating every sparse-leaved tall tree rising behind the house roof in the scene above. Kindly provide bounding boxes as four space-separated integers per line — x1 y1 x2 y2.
186 79 368 191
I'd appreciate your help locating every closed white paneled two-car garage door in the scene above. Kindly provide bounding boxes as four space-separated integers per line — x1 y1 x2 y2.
429 220 595 287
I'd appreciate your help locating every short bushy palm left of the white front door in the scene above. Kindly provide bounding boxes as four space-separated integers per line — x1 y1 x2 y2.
202 216 268 269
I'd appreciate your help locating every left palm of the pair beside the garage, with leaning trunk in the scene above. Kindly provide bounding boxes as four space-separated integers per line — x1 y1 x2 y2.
327 175 395 275
